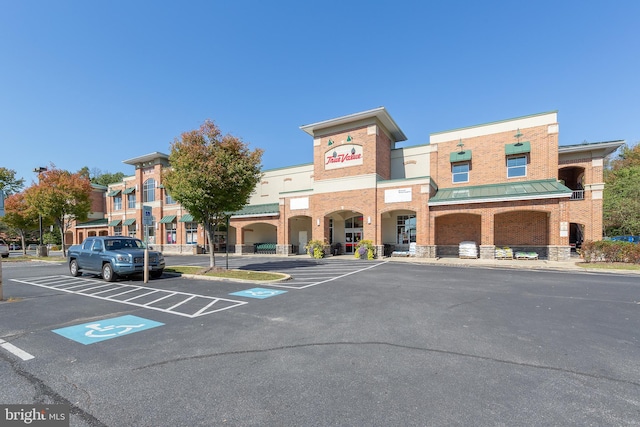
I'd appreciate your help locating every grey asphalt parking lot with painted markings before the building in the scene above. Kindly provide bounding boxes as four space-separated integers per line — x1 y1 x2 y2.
0 257 640 426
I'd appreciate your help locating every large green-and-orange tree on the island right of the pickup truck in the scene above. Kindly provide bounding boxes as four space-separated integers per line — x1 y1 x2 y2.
163 120 263 267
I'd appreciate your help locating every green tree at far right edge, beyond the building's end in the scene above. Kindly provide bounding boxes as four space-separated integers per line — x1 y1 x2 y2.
603 144 640 236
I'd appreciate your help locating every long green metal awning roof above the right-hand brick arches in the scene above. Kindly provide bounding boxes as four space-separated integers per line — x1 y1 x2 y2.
429 179 573 206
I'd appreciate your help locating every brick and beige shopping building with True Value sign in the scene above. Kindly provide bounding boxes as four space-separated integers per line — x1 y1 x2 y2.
74 107 624 260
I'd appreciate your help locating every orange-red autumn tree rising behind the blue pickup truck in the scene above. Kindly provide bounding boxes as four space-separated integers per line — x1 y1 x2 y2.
25 165 91 256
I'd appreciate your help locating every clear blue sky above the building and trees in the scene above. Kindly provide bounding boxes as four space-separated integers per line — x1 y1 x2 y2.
0 0 640 185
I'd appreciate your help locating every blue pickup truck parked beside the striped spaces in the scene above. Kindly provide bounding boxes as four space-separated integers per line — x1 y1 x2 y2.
67 236 164 282
